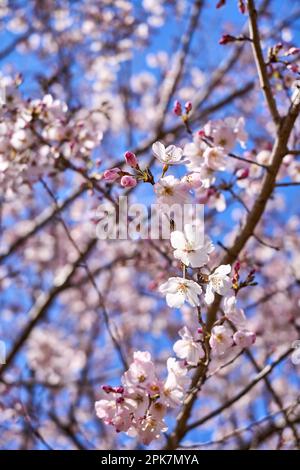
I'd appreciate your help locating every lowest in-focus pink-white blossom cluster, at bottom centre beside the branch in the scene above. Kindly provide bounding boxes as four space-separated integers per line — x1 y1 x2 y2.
95 351 189 445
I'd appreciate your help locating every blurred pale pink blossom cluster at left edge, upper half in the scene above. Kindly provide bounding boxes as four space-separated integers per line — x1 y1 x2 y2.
0 77 103 197
